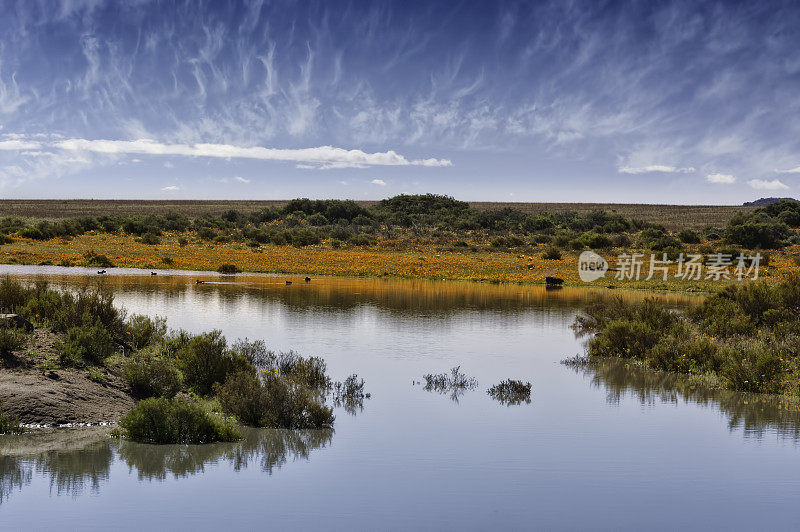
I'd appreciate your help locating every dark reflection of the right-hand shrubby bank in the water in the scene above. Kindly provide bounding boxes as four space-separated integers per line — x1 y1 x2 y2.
572 359 800 442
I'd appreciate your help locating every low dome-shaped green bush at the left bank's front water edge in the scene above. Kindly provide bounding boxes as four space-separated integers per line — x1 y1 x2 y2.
116 397 242 444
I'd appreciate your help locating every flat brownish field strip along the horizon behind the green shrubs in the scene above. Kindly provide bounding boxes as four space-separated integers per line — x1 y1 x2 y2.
0 200 756 230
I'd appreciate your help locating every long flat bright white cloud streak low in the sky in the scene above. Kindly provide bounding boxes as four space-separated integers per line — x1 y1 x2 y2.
52 138 453 168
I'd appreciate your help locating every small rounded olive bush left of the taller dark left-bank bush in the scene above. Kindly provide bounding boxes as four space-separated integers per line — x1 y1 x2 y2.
122 351 181 399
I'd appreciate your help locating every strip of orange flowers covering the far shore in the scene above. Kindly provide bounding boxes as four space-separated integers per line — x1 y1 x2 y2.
0 232 800 292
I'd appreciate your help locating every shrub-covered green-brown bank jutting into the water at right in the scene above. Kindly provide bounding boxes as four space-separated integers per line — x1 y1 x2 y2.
575 276 800 397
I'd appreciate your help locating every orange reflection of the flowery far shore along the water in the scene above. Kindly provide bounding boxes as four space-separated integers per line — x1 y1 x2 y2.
0 265 699 318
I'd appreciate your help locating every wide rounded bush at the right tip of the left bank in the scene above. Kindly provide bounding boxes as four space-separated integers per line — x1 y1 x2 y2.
214 371 334 429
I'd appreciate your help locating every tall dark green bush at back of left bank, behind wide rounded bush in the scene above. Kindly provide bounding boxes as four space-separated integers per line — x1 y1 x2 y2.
177 331 254 395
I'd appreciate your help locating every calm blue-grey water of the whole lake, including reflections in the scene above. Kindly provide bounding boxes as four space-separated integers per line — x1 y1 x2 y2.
0 267 800 530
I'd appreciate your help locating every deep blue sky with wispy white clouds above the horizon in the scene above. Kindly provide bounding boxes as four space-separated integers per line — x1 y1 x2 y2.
0 0 800 204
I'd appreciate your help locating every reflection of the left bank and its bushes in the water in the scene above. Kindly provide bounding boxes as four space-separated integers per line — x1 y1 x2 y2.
0 427 334 505
